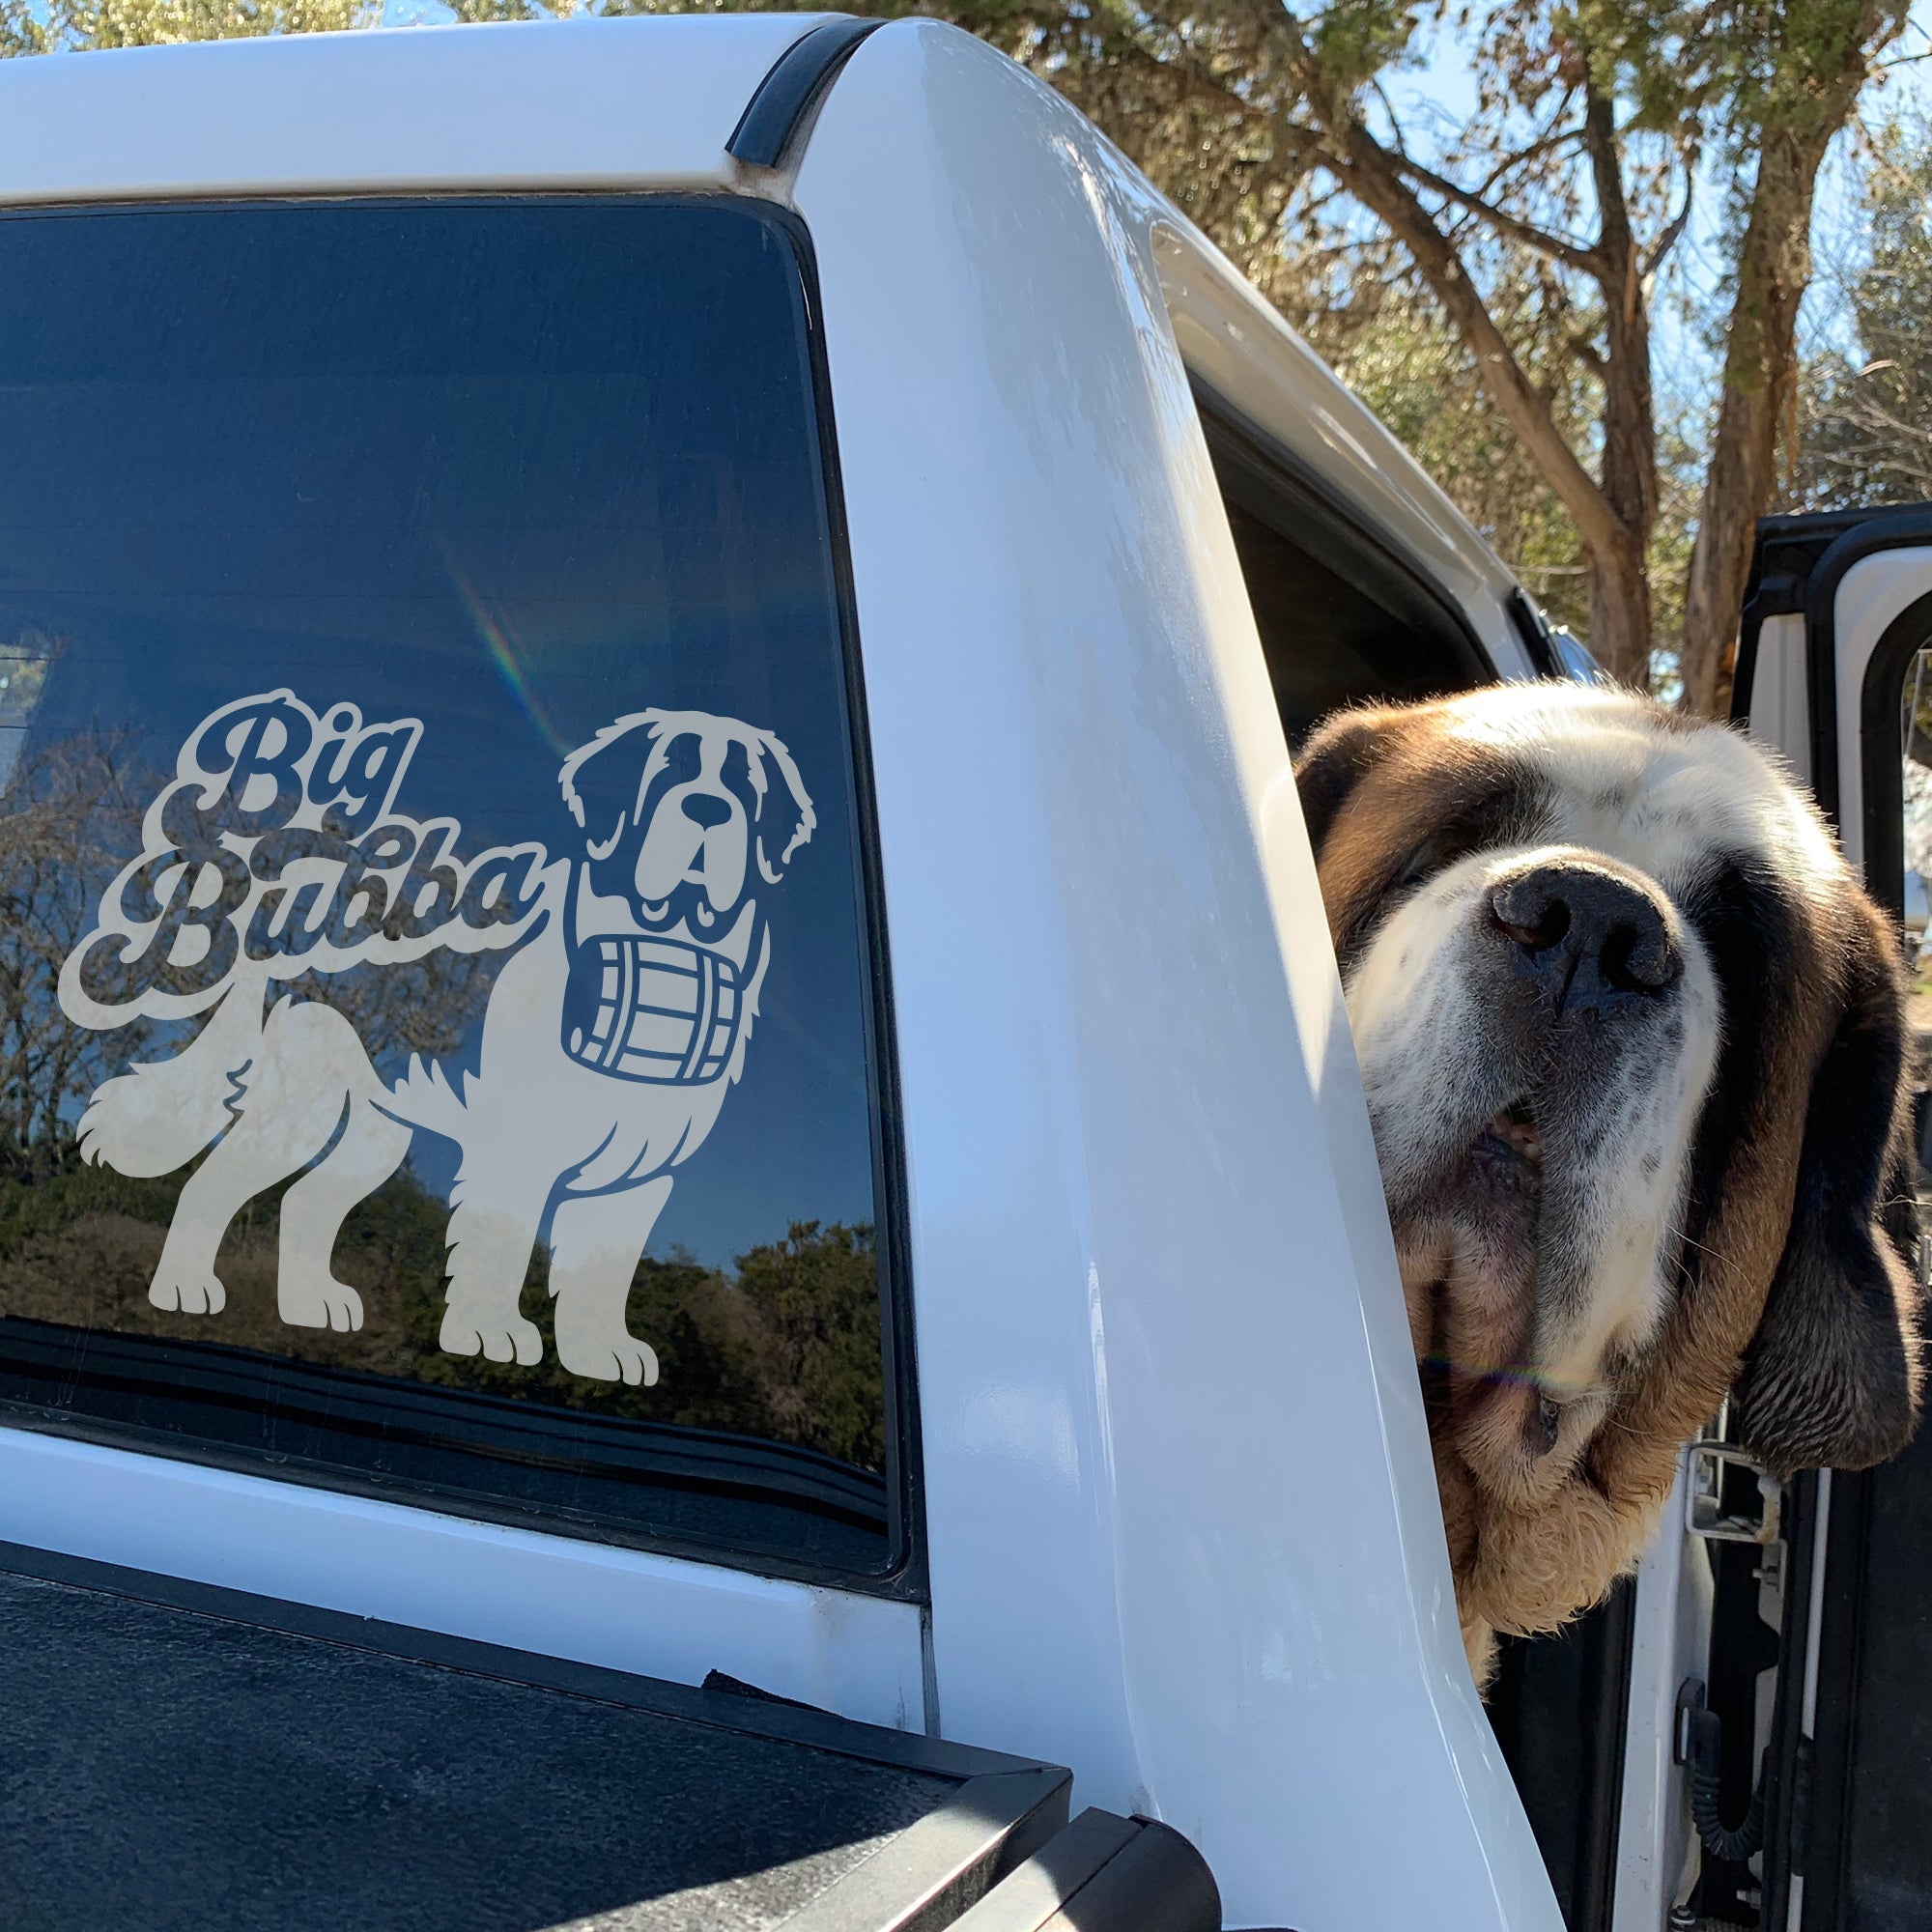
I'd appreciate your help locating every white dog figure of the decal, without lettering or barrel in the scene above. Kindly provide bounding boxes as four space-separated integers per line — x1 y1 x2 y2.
79 711 815 1383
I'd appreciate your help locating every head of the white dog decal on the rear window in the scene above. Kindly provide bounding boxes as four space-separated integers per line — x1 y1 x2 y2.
558 711 817 945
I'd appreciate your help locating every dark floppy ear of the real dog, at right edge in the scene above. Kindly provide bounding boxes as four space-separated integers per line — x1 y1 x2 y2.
1737 902 1920 1474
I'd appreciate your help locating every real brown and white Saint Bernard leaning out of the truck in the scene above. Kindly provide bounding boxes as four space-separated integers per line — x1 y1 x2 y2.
1296 684 1920 1681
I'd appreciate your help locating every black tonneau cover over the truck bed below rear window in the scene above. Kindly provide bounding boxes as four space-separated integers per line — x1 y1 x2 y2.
0 1544 1219 1932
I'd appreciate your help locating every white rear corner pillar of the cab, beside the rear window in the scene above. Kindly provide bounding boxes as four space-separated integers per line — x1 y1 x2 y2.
796 21 1557 1932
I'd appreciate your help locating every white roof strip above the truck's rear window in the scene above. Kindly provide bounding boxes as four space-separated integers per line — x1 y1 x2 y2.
0 14 825 205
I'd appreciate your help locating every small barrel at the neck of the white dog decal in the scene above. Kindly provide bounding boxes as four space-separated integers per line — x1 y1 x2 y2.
564 935 744 1086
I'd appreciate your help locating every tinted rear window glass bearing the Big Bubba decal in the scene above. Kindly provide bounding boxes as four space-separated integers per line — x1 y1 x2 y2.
0 201 896 1573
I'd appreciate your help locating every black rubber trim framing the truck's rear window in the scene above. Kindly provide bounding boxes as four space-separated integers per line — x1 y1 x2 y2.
0 188 931 1607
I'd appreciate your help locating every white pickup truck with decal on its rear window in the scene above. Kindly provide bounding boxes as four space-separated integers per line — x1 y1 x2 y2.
0 15 1932 1932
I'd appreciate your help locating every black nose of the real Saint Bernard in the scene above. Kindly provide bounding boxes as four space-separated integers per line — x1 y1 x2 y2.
1490 860 1683 1012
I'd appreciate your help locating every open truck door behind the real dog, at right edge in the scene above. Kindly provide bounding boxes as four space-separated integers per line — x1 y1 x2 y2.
1692 504 1932 1932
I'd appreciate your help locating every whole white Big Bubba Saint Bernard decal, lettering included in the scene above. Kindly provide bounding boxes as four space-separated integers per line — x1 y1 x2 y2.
60 690 815 1383
